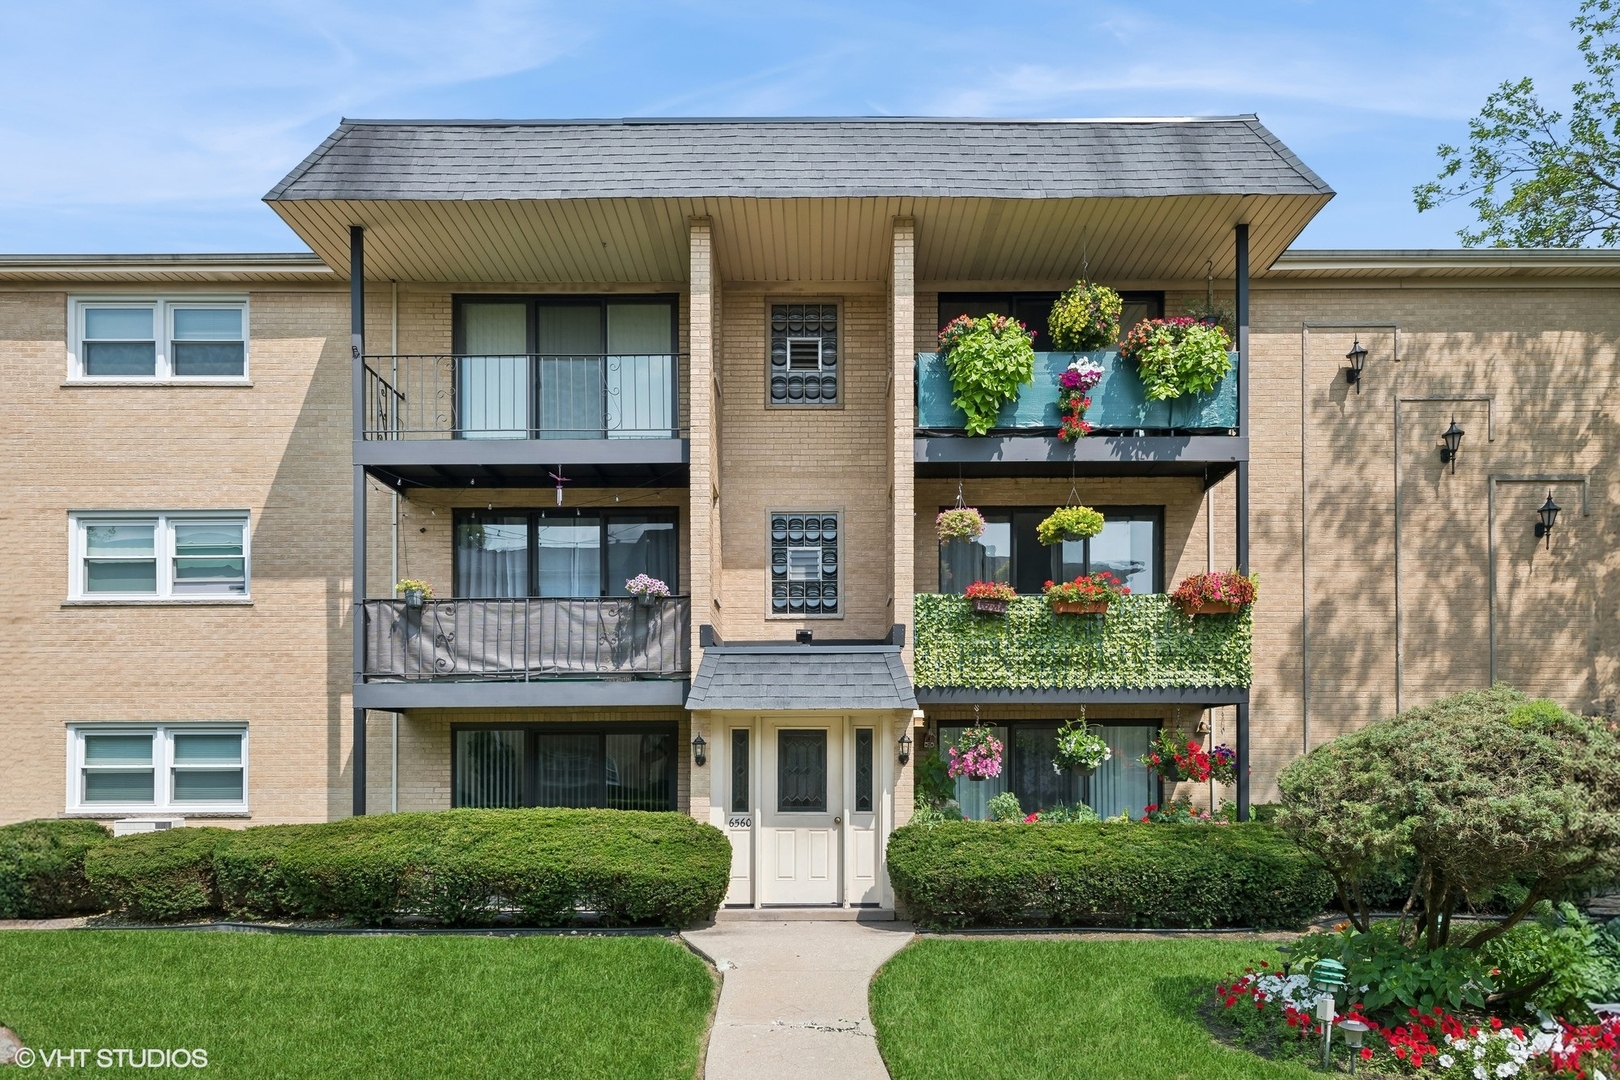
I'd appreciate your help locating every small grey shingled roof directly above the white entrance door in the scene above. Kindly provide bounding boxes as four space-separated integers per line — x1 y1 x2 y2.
687 644 917 709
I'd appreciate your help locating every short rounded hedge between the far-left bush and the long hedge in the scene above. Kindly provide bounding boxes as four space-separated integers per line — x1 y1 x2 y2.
84 827 238 923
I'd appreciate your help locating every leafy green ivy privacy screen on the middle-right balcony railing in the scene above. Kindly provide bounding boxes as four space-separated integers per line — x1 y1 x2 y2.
915 593 1254 690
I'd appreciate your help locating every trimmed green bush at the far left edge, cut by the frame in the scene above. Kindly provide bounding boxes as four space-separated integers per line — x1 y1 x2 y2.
0 818 112 918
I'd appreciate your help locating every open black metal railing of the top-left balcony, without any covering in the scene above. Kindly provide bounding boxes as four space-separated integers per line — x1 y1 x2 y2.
365 353 680 439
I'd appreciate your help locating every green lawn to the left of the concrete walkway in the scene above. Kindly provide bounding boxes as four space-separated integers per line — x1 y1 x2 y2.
0 931 714 1080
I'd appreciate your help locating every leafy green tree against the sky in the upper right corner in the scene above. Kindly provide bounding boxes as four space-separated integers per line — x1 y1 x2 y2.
1413 0 1620 248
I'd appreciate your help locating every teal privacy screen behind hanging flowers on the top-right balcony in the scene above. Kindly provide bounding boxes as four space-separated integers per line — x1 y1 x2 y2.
917 351 1238 432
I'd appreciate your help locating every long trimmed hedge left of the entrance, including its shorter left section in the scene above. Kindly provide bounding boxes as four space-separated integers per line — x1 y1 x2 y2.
82 810 731 926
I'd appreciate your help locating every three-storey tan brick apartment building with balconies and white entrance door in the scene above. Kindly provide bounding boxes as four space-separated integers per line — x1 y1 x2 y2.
0 117 1620 907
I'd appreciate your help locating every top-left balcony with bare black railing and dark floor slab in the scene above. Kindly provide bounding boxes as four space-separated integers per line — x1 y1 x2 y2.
355 353 687 486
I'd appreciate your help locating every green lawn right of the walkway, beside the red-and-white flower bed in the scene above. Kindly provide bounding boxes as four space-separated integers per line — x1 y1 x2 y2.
872 938 1320 1080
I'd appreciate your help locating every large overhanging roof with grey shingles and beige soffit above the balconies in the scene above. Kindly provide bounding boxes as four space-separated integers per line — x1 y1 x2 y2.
266 115 1333 283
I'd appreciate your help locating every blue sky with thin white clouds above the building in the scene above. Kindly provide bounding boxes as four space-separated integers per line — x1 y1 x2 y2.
0 0 1580 253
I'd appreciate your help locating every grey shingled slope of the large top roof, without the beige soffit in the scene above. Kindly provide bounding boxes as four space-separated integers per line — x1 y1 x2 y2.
264 115 1332 202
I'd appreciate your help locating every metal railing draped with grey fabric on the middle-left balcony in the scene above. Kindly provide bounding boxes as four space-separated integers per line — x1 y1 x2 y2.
365 596 692 682
